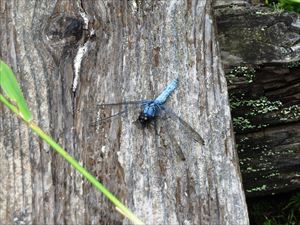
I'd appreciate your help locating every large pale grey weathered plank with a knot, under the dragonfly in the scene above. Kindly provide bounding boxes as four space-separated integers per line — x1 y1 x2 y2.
0 0 248 225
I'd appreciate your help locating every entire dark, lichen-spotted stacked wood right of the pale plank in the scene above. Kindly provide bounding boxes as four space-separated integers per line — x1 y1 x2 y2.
216 4 300 197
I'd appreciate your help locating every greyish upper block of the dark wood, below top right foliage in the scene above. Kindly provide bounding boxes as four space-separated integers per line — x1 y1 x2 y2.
215 5 300 66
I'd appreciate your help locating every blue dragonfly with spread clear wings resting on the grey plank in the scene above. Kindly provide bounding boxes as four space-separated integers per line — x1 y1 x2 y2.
95 79 204 158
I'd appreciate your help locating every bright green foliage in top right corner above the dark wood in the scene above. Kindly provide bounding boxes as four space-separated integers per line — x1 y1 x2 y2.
265 0 300 13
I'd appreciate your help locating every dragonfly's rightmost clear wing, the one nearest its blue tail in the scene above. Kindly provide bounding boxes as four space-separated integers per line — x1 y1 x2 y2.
161 106 204 145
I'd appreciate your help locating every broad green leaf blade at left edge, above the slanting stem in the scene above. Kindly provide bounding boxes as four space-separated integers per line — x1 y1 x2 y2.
0 60 32 122
